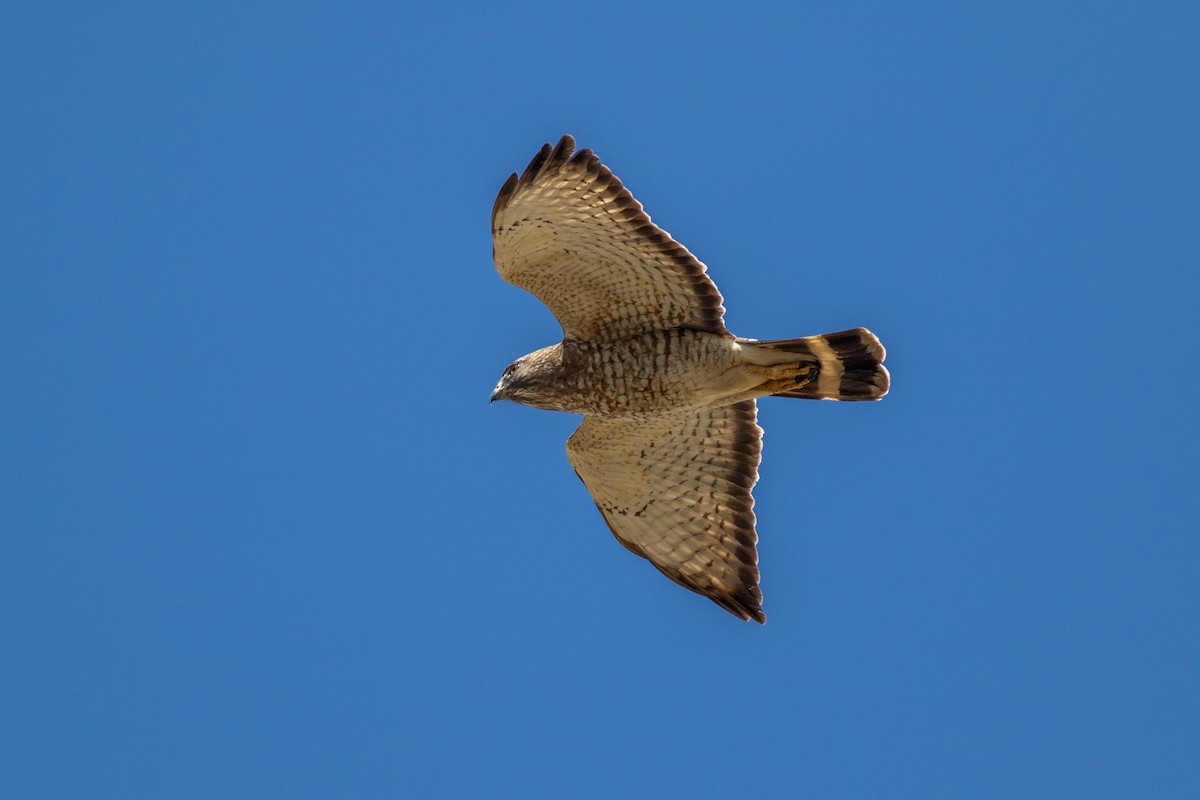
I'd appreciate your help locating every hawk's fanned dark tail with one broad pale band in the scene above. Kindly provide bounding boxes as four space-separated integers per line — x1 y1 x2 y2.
740 327 890 401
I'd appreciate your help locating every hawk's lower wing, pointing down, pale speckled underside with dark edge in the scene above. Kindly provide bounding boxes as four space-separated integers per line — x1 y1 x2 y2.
566 401 767 622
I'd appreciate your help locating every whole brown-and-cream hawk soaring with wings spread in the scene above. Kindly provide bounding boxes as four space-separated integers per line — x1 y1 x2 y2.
492 136 889 622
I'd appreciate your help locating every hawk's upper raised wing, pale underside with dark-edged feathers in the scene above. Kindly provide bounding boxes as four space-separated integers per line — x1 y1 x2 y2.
492 136 726 341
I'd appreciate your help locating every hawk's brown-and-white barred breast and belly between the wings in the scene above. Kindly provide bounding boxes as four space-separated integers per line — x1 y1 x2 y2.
552 330 762 419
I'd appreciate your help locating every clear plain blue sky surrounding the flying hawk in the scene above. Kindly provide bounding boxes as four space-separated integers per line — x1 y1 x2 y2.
0 2 1200 800
